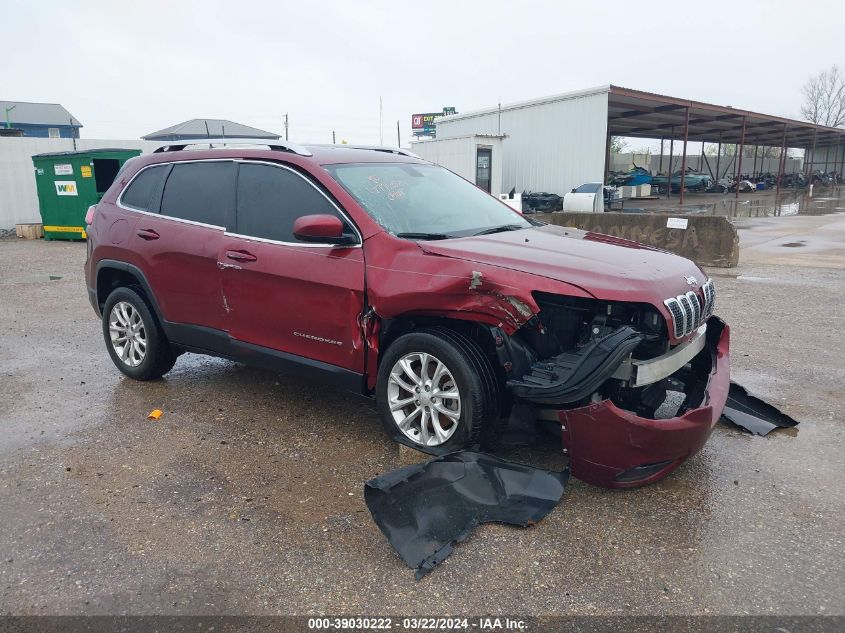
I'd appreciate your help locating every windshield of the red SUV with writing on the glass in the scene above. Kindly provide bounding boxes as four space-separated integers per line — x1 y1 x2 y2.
326 163 532 239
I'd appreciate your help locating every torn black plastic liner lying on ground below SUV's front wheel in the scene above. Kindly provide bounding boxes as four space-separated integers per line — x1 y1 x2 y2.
364 451 569 580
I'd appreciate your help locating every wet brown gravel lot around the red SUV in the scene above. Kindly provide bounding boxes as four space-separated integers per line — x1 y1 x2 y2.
0 214 845 615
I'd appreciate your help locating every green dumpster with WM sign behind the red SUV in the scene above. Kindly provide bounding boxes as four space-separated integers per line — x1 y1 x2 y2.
32 149 141 240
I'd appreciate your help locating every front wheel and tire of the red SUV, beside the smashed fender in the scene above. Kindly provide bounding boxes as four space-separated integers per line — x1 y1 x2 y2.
376 327 501 455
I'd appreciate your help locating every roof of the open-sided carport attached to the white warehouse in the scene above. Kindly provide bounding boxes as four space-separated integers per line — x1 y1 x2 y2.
608 86 845 147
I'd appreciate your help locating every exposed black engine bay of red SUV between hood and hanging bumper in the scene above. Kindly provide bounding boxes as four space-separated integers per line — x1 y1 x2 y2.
496 293 718 419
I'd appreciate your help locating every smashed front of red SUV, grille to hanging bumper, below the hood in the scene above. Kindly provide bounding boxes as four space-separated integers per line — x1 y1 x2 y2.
497 281 729 488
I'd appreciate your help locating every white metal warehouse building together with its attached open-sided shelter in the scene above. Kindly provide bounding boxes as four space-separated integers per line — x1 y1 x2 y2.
426 85 845 200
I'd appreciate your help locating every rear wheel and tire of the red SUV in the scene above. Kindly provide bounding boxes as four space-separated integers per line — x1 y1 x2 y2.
102 287 177 380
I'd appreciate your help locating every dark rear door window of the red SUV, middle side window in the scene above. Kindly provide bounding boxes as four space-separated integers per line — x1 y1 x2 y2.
161 161 237 230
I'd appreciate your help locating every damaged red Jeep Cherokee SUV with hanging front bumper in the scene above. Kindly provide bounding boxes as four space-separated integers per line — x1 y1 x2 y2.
85 139 729 487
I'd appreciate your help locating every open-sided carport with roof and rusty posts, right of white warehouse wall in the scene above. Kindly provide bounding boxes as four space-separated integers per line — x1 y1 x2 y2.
605 86 845 203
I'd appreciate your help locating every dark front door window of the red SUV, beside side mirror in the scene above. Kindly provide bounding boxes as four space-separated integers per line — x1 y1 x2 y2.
235 163 342 242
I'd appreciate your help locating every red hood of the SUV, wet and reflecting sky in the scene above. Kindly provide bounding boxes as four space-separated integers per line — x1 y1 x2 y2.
420 225 707 310
